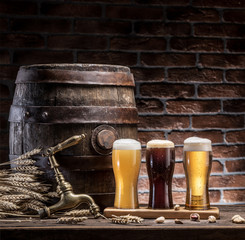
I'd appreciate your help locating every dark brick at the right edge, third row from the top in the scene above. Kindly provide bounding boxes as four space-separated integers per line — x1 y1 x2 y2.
194 23 245 37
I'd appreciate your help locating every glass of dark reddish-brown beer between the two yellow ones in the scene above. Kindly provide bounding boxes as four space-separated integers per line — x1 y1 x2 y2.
146 140 175 208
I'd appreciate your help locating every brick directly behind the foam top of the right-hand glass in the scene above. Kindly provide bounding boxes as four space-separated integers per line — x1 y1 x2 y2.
168 131 223 145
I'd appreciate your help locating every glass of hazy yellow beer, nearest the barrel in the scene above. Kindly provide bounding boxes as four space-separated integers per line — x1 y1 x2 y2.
112 139 141 208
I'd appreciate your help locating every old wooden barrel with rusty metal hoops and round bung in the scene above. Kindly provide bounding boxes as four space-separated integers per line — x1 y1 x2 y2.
9 64 138 209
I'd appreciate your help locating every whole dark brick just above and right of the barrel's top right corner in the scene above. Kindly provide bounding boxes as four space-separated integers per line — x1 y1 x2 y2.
141 53 196 66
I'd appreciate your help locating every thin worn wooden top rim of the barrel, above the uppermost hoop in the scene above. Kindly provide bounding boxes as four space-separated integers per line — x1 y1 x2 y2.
20 63 130 73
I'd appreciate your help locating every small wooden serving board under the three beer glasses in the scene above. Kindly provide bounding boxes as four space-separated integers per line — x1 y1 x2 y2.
104 207 220 219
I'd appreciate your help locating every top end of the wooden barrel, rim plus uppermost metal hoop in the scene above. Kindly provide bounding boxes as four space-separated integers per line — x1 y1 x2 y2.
15 64 135 87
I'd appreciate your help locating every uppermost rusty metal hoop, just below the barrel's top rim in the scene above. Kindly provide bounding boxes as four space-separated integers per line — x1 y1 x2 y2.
15 68 135 87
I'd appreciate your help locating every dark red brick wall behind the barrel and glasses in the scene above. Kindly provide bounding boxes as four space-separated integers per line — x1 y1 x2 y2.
0 0 245 204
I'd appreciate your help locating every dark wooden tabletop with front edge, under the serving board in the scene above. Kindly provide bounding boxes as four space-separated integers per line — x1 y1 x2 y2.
0 205 245 240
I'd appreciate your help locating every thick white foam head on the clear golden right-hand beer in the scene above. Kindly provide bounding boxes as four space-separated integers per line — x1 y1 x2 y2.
184 137 212 151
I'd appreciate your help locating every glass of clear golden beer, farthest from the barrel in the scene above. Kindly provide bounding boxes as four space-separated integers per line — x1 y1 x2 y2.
183 137 212 210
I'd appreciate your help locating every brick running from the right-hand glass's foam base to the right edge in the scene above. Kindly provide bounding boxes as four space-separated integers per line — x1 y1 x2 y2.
213 145 245 158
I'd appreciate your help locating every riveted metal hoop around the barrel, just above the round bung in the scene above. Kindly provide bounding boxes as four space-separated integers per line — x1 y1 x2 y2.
9 105 138 124
